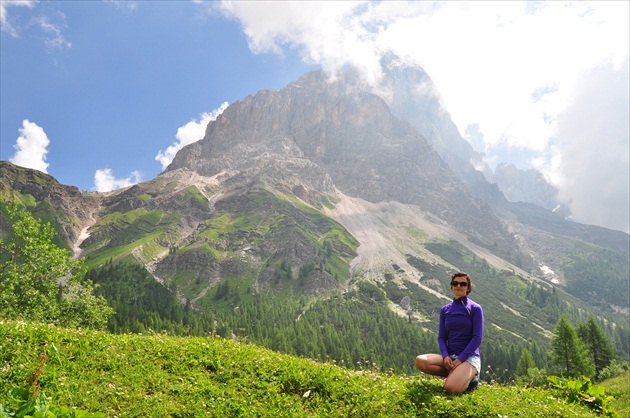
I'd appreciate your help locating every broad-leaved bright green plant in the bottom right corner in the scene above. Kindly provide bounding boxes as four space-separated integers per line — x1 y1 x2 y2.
547 376 617 417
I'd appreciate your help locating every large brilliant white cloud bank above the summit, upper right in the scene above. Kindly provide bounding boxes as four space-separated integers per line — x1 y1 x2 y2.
220 1 630 232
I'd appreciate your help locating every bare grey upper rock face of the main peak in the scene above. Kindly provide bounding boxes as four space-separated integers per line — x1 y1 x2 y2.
167 72 516 252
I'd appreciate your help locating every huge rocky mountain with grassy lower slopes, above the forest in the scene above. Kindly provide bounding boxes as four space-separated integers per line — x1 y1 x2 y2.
0 70 630 372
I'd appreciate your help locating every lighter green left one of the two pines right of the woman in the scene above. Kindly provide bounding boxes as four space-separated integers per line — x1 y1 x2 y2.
551 314 595 377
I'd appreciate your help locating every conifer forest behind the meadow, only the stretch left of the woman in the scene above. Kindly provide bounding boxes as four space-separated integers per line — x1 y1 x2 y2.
87 263 437 373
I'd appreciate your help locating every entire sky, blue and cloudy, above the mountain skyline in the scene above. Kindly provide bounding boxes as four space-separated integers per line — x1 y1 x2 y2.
0 0 630 232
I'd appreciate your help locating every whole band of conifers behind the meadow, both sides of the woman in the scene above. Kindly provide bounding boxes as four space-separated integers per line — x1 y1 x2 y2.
87 263 619 383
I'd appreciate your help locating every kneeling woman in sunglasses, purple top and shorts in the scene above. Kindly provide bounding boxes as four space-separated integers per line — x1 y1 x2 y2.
416 272 483 393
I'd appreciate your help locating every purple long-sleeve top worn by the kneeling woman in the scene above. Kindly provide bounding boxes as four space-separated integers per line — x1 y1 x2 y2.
438 296 483 361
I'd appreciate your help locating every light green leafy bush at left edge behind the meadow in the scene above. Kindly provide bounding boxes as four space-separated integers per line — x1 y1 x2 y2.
0 204 113 328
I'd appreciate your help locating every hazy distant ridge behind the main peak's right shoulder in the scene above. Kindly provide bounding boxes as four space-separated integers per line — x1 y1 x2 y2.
366 63 570 237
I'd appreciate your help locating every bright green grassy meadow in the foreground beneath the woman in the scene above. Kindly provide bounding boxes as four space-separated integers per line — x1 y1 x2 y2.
0 322 616 418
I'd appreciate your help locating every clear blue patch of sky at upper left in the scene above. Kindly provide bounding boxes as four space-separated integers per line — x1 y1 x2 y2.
1 1 316 190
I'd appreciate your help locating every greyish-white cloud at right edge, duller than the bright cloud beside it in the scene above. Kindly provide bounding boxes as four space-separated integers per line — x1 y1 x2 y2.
550 61 630 232
